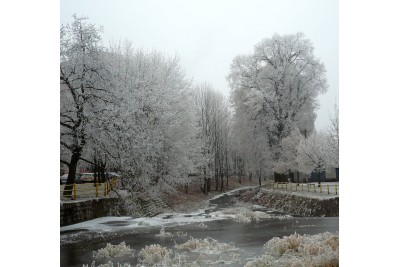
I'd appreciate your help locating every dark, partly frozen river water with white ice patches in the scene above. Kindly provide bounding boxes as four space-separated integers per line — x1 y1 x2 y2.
60 189 339 267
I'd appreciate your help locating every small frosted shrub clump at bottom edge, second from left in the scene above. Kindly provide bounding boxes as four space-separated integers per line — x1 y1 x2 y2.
138 244 171 266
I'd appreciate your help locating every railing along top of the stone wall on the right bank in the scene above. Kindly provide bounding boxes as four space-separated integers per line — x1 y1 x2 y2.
272 182 339 195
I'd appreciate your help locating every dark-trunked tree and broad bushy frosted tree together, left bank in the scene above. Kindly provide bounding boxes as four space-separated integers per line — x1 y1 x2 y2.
60 16 198 195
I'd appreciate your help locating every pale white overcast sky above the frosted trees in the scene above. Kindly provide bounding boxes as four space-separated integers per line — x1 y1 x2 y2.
60 0 339 130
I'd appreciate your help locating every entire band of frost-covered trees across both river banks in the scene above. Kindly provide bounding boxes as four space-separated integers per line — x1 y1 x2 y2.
60 16 338 198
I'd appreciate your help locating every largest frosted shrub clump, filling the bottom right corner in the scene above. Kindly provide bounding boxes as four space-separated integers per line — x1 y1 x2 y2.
245 233 339 267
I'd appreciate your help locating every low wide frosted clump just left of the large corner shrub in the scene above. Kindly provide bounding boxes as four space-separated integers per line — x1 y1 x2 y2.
176 237 237 254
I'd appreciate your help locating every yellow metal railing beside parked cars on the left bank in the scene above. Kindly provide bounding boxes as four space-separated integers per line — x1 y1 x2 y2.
60 178 118 200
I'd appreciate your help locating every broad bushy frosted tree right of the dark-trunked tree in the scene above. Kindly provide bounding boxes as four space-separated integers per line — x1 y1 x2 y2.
97 43 196 194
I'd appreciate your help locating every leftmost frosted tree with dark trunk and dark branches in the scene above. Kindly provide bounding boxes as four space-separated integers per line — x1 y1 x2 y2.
60 15 111 187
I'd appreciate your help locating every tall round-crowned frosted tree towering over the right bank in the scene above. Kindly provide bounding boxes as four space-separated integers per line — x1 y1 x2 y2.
227 33 327 161
